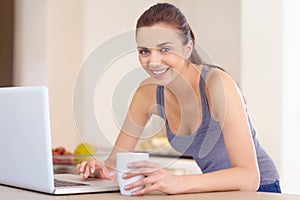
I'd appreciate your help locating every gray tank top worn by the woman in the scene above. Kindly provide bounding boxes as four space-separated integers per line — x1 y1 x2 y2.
156 66 279 185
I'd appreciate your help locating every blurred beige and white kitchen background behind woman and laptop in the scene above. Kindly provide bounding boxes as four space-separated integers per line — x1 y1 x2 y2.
0 0 300 194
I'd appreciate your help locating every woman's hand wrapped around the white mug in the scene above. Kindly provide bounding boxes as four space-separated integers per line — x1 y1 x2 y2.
123 161 183 195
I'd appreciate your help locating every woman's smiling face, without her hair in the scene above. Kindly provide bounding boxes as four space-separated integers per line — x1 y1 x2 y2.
136 24 191 85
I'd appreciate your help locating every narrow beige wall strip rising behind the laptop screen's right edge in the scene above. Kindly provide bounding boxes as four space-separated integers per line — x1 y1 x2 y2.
46 0 85 151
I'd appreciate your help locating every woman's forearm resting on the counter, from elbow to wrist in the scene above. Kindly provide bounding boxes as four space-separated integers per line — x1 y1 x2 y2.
179 167 259 193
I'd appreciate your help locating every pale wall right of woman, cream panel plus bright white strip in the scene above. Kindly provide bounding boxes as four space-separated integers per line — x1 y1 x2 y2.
241 0 300 194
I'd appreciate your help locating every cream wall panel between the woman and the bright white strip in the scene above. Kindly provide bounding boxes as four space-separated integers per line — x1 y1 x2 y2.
241 0 283 180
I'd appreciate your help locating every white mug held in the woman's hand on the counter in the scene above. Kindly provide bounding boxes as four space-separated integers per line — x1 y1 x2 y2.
117 152 149 195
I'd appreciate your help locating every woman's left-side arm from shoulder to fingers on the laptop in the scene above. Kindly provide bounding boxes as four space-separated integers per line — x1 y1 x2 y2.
77 85 156 179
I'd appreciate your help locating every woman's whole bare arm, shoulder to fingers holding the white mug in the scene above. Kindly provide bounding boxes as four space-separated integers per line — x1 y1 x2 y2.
124 70 260 195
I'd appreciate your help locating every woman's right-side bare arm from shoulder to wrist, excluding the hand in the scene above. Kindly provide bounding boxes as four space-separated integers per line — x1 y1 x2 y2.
178 70 260 193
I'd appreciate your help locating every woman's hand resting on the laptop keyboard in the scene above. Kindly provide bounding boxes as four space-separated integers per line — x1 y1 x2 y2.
76 158 116 180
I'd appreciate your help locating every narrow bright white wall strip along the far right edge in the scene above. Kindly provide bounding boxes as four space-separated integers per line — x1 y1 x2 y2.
281 0 300 194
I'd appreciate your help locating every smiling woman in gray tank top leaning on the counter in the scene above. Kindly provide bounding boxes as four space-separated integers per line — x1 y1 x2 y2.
77 3 280 195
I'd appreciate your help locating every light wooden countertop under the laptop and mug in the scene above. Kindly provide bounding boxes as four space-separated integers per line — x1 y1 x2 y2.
0 185 300 200
